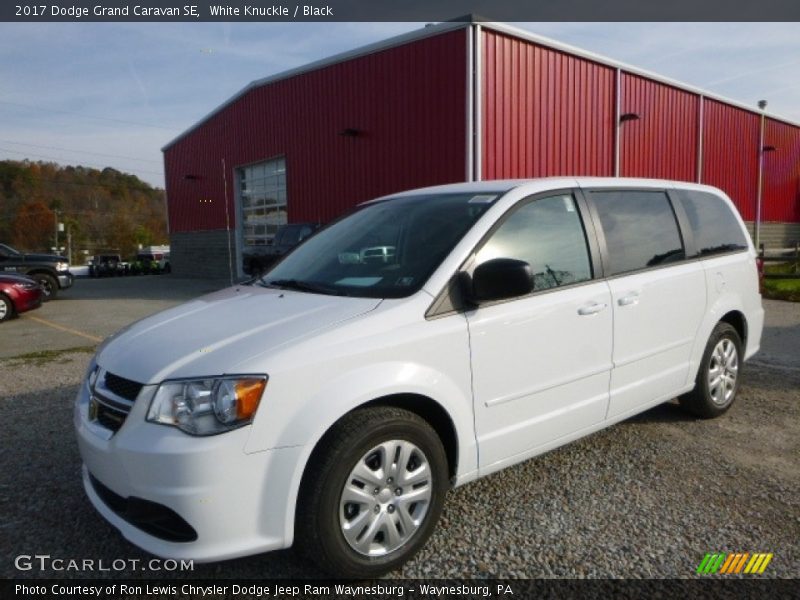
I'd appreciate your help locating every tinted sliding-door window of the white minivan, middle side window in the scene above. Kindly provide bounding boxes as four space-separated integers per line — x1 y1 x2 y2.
591 190 686 275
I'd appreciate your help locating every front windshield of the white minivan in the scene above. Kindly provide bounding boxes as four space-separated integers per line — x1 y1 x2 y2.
260 193 499 298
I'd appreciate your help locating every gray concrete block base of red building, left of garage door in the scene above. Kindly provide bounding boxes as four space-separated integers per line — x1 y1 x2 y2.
169 229 237 280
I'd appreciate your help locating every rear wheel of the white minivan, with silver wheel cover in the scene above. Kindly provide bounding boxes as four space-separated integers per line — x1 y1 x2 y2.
679 323 743 419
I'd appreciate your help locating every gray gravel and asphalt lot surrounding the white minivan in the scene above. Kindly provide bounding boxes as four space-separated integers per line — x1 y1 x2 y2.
0 281 800 579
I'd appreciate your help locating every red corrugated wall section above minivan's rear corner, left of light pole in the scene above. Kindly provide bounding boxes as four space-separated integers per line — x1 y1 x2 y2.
702 98 761 221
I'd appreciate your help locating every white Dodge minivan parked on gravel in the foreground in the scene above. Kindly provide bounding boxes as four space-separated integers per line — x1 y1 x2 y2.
74 178 764 577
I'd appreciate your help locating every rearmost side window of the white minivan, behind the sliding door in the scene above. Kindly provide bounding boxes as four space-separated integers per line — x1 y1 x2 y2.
678 190 747 256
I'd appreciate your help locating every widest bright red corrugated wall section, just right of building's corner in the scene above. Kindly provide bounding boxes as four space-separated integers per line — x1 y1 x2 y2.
480 30 614 179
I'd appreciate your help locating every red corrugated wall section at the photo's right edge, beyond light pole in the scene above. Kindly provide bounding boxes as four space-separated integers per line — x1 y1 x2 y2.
761 119 800 223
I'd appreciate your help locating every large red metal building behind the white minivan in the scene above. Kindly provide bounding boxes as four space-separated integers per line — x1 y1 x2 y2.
164 22 800 276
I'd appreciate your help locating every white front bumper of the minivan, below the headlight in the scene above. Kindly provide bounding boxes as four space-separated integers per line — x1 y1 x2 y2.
74 378 302 562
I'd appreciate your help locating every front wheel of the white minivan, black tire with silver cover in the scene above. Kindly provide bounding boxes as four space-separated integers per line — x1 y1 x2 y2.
296 407 448 578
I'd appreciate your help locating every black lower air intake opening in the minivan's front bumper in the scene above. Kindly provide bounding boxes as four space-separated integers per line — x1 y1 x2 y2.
89 473 197 542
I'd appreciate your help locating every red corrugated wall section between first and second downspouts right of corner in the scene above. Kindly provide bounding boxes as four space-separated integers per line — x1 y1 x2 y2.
620 71 699 181
